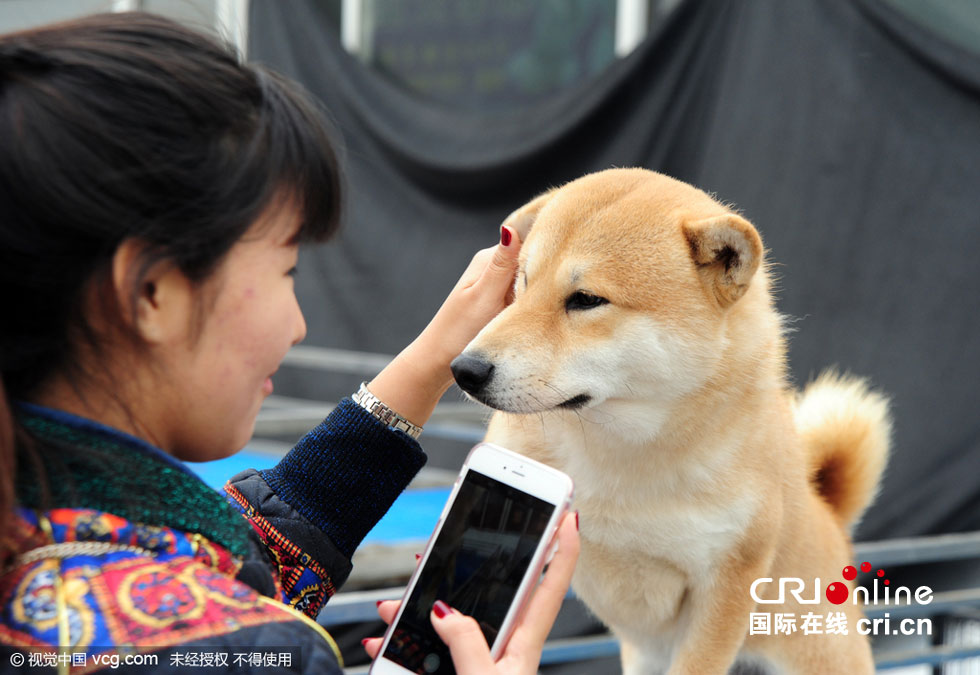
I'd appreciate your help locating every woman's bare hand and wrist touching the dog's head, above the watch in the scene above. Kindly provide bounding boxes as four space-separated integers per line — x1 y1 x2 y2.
368 227 521 426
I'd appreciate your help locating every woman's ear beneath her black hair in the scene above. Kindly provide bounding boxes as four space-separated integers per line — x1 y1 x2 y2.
112 238 194 344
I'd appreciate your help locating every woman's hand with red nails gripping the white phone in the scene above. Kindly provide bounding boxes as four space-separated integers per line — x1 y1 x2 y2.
364 513 579 675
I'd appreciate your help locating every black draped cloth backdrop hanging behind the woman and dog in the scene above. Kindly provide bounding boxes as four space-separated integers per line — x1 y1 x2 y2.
249 0 980 540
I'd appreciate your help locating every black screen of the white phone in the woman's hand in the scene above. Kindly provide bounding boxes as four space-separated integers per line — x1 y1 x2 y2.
384 469 556 675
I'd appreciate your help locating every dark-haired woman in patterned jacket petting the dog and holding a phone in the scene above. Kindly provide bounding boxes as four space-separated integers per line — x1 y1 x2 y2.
0 13 578 673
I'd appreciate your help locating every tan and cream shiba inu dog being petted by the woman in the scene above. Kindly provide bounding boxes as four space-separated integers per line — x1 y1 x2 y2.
453 169 890 675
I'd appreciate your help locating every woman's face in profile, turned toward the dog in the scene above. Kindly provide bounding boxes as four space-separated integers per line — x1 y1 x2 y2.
156 207 306 461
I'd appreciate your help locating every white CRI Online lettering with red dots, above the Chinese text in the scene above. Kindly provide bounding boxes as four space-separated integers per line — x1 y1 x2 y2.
749 562 933 605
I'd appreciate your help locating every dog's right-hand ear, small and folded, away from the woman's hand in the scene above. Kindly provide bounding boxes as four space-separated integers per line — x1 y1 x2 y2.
683 213 762 307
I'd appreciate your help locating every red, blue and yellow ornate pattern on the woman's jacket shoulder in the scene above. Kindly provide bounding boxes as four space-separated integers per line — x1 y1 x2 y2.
0 509 304 653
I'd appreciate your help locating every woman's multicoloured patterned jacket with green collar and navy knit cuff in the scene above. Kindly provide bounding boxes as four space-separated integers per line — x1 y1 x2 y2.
0 399 425 675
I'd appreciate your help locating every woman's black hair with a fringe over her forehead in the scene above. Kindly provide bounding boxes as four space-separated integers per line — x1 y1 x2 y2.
0 12 341 548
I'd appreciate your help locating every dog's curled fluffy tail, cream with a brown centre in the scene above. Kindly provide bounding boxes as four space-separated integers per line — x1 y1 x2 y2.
795 371 892 529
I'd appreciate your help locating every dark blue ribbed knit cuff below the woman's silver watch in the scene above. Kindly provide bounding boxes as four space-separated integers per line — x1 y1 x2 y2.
259 398 426 558
